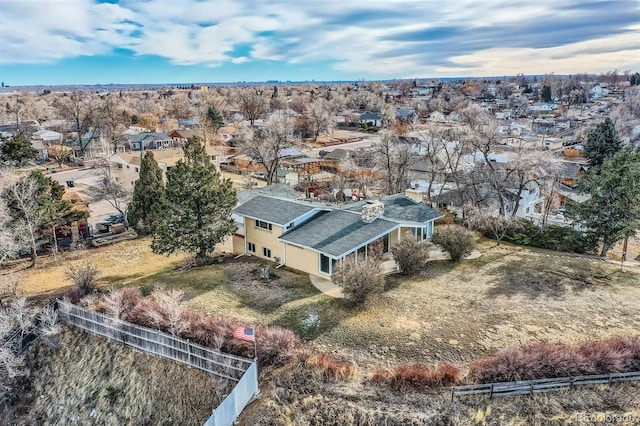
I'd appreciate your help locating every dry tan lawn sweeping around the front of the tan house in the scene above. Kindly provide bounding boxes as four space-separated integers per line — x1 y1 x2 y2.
20 239 640 367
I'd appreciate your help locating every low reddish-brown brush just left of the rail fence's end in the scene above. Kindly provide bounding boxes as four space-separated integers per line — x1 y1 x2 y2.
371 363 462 390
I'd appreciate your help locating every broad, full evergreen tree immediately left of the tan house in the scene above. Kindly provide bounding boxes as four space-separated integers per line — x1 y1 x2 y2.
151 139 237 263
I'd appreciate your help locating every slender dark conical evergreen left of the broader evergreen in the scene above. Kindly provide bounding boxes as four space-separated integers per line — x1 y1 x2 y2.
127 151 165 234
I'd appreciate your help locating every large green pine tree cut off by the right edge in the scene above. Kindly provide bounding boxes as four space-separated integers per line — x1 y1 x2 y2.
566 148 640 256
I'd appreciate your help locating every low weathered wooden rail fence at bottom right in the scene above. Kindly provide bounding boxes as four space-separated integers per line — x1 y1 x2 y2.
451 371 640 400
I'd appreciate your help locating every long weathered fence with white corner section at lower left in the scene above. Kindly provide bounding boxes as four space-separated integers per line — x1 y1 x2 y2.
58 301 260 426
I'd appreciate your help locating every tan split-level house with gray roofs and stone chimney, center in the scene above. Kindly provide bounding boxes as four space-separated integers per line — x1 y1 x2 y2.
233 194 442 277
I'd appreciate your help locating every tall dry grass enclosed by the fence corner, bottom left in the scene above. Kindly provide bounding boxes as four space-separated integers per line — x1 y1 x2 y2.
11 328 233 426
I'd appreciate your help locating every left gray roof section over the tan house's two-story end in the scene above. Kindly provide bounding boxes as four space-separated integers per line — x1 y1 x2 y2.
234 195 318 225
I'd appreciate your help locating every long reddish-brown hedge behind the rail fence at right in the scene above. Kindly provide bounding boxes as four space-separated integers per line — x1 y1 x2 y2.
469 336 640 383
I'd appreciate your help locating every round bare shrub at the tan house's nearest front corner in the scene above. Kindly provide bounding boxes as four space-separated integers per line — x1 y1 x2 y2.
332 256 385 305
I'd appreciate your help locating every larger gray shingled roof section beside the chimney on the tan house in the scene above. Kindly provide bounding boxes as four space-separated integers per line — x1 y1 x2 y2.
280 210 398 257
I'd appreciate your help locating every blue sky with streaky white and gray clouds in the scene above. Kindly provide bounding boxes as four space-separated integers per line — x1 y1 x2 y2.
0 0 640 85
